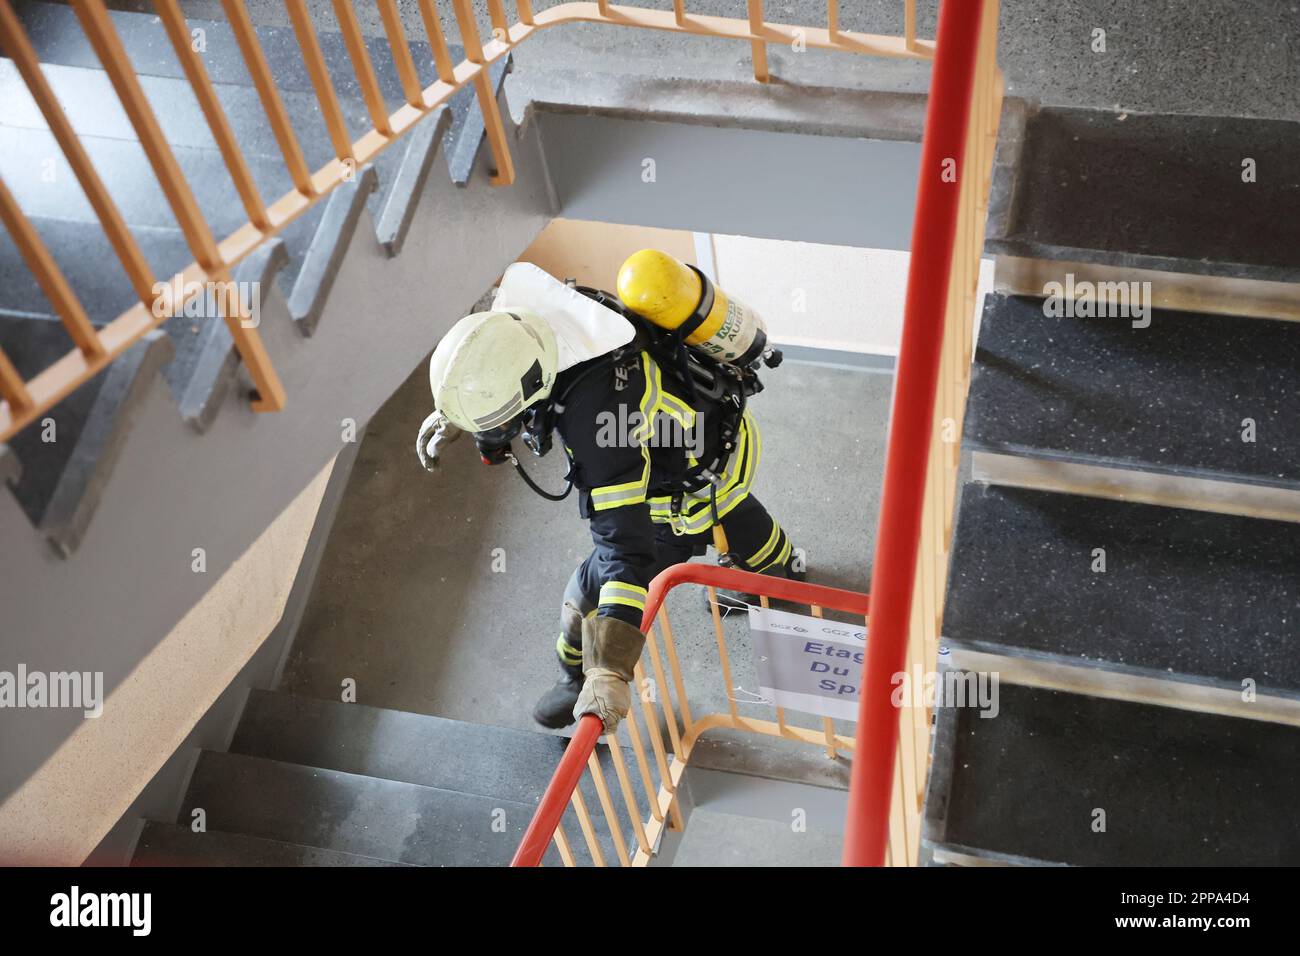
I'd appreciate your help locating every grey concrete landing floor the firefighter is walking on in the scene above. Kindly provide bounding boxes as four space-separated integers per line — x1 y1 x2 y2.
281 348 893 728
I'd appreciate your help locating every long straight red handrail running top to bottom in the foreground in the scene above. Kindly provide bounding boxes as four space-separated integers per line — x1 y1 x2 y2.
844 0 984 866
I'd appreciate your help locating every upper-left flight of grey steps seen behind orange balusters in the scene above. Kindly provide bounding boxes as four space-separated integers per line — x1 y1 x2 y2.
0 3 508 557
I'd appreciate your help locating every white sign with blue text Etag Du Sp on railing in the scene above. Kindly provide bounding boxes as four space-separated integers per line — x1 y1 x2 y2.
749 607 867 721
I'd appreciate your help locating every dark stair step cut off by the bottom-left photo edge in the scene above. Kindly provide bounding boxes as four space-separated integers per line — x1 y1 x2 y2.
131 821 407 866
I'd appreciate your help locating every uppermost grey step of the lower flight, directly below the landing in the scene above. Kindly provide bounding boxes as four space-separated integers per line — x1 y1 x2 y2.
230 691 629 864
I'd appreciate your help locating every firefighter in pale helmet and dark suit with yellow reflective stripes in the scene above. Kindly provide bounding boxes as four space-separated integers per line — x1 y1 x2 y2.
416 254 802 734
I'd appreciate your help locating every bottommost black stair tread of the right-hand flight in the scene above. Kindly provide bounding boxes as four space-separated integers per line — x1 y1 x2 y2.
927 684 1300 866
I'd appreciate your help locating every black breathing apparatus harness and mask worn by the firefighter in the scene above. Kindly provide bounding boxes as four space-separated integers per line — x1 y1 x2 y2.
475 280 783 512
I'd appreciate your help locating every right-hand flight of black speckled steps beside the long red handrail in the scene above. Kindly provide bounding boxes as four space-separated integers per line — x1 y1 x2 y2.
924 102 1300 865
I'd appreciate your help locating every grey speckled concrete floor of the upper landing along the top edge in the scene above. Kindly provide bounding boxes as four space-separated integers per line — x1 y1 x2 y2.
137 0 1300 120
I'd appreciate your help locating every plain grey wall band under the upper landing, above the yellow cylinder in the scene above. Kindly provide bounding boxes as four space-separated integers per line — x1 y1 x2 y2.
541 113 920 250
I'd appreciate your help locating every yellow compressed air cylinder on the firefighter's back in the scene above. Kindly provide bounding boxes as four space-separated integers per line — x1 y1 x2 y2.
619 248 767 365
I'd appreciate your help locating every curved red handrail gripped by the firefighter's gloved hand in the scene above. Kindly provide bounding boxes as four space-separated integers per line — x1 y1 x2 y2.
511 563 871 866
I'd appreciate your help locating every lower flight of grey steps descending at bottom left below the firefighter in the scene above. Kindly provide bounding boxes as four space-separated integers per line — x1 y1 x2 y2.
133 691 595 866
